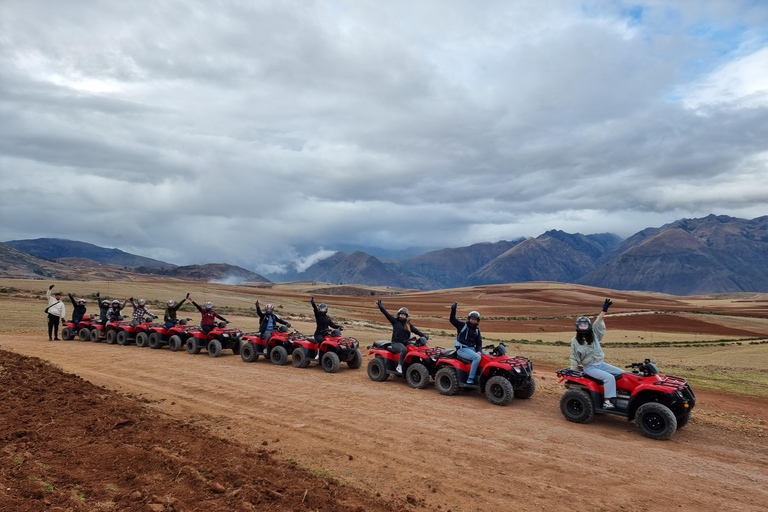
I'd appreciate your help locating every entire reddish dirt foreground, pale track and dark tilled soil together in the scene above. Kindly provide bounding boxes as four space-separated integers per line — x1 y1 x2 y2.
0 334 768 512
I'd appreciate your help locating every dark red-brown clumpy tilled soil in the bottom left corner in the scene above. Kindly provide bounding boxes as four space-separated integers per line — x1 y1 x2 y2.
0 350 393 511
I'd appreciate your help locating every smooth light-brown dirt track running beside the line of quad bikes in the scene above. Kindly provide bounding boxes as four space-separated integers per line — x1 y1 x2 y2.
0 335 768 511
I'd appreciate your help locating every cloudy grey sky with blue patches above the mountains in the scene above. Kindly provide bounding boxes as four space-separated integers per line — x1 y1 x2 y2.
0 0 768 274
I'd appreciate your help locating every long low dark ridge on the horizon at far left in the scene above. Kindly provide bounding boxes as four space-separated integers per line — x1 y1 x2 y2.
5 238 175 267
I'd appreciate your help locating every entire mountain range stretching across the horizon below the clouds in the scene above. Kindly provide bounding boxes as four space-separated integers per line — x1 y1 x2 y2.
6 215 768 295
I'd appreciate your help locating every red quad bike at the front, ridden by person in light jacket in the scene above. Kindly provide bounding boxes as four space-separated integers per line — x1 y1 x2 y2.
557 359 696 439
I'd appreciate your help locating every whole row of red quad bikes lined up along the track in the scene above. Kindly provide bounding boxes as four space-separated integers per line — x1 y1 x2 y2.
62 315 696 439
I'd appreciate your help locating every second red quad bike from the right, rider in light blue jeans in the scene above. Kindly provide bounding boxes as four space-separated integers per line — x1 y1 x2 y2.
435 343 536 405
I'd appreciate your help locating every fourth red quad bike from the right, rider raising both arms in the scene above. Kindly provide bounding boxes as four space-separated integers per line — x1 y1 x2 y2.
291 329 363 373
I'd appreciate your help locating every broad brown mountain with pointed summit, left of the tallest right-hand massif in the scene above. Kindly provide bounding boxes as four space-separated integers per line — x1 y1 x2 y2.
463 230 620 286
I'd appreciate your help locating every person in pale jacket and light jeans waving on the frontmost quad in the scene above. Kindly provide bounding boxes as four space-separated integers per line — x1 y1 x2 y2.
571 299 623 409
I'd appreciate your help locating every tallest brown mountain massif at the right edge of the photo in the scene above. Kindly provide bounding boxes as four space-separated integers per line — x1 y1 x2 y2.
577 215 768 295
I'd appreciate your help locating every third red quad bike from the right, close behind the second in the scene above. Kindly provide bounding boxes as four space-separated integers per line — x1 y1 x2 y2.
368 337 445 389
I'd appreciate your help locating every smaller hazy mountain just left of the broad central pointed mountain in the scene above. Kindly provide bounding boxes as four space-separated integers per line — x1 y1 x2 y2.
399 238 524 288
